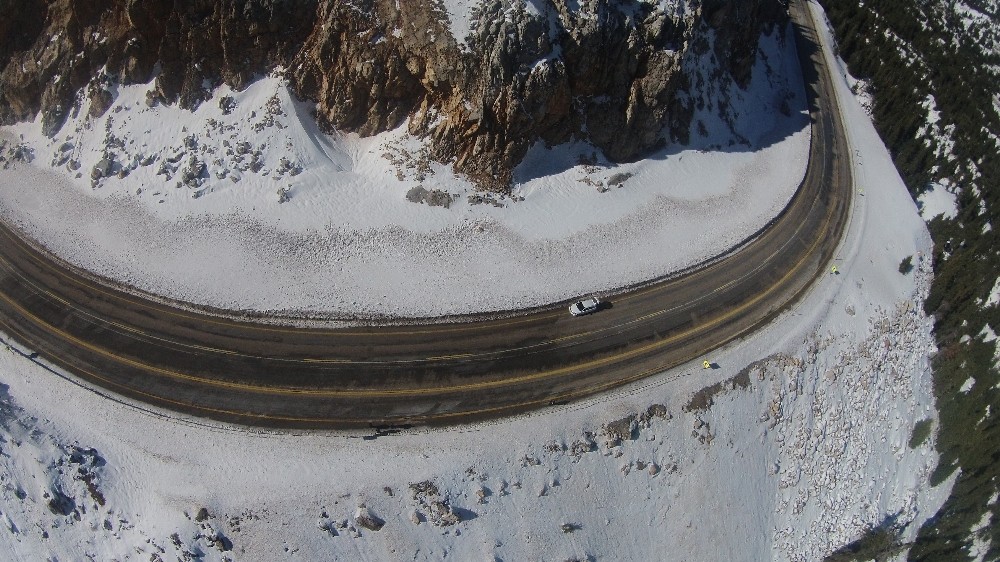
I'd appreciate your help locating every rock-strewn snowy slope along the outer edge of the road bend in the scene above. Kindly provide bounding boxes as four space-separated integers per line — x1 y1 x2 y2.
0 6 950 560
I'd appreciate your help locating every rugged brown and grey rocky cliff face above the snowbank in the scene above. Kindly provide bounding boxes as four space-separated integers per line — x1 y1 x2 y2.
0 0 786 190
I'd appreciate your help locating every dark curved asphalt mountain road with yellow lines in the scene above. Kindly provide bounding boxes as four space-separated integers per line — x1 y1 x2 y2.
0 2 852 428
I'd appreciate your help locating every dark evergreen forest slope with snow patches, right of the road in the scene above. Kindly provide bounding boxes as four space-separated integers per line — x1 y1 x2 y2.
821 0 1000 561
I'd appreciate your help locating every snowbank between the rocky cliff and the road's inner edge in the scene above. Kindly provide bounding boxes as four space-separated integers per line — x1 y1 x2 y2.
0 26 809 318
